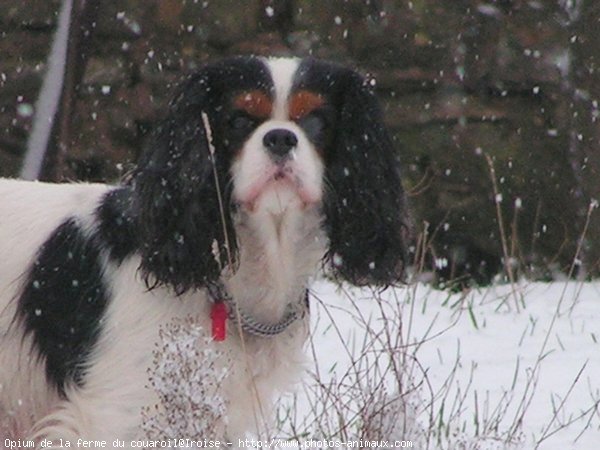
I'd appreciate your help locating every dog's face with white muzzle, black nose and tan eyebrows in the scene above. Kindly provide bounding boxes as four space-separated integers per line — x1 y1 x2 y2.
220 59 333 214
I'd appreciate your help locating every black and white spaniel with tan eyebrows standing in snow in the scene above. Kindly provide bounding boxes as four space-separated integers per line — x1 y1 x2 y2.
0 57 407 442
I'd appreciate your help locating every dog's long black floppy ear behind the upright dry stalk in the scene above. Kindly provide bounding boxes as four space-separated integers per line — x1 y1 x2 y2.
133 70 236 294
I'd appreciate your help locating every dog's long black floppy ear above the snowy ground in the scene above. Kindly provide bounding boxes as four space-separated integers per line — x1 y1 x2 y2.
325 71 409 286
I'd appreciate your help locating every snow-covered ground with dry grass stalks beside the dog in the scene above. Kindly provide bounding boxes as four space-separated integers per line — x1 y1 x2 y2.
279 282 600 450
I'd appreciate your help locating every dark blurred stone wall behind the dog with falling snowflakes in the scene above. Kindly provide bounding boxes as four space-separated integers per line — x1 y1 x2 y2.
0 0 600 286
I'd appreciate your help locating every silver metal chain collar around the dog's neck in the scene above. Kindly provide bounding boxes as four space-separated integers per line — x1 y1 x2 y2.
207 282 304 338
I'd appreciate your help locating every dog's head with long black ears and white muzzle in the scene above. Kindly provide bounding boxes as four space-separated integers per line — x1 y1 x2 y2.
133 57 406 292
